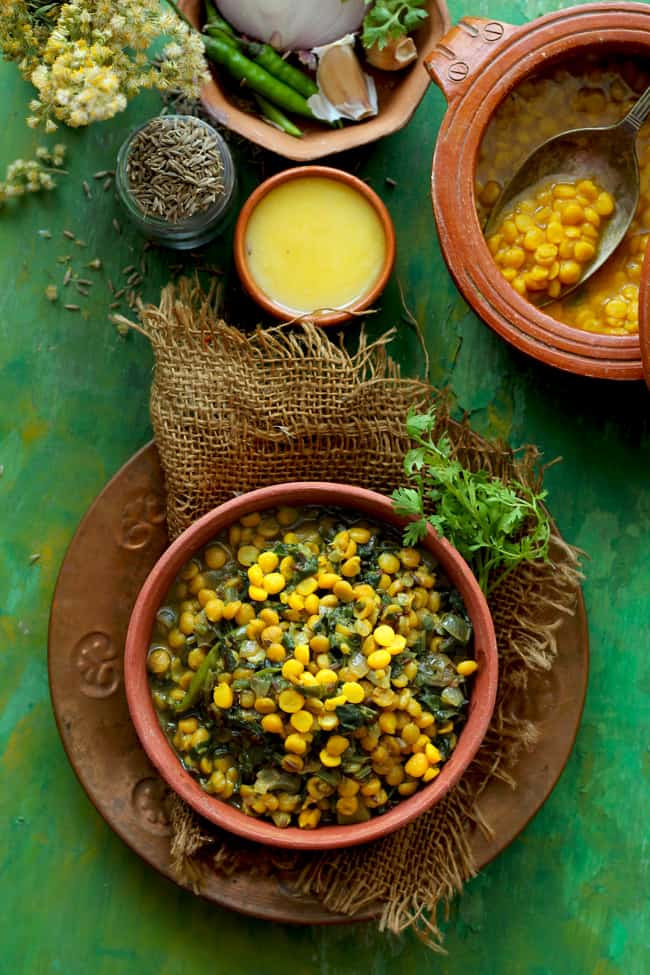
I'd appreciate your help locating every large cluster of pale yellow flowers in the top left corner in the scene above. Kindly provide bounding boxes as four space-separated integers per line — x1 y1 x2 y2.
0 0 207 132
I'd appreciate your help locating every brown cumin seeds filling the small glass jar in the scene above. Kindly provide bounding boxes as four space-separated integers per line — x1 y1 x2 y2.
127 116 224 223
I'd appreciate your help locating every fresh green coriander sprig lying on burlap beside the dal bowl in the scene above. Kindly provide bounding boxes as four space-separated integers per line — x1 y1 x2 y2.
392 408 551 594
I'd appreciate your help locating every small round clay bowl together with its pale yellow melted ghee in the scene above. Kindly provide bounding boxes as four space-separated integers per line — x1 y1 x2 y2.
234 166 395 325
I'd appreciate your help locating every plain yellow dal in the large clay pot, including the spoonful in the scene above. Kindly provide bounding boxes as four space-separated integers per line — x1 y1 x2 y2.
476 57 650 335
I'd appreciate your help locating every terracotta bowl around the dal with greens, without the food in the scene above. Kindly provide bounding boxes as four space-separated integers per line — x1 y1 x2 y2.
124 481 498 850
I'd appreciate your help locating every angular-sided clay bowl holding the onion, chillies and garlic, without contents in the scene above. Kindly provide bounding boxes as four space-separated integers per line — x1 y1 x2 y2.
179 0 451 162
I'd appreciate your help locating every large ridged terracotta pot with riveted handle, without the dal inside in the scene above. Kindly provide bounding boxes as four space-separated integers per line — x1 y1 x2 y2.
425 3 650 379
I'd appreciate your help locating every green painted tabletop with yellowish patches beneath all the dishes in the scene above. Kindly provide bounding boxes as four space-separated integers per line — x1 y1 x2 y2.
0 0 650 975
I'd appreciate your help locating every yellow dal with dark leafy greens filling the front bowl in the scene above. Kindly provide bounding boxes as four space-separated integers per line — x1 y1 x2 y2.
147 506 477 829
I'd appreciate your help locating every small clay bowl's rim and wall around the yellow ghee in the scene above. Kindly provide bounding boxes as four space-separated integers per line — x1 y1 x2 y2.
233 166 395 325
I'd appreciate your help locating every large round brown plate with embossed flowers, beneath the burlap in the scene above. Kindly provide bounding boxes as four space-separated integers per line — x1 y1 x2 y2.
49 444 589 924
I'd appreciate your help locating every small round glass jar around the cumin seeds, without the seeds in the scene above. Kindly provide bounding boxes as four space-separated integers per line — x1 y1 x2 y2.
115 115 237 250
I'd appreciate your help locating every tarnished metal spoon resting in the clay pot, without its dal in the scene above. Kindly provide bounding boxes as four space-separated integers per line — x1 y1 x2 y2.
484 87 650 308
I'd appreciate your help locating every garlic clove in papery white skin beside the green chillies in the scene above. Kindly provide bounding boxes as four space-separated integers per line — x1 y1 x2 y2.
308 34 378 122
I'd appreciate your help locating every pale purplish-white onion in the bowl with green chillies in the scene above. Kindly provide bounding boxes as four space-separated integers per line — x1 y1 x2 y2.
216 0 366 51
